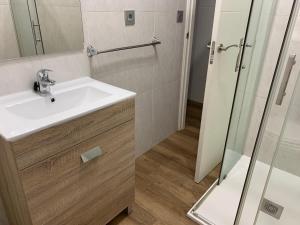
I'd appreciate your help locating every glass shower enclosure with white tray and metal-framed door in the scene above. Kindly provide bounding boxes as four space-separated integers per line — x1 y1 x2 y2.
188 0 300 225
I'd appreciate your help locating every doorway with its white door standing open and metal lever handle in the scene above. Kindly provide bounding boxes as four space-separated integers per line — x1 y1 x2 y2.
179 0 260 183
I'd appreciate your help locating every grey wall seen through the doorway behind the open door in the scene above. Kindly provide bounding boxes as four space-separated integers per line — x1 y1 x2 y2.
188 0 215 103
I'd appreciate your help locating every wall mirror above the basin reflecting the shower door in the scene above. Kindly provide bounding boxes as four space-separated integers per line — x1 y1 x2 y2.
0 0 83 61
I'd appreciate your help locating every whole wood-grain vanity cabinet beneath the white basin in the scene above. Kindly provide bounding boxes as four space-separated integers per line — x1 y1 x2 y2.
0 99 135 225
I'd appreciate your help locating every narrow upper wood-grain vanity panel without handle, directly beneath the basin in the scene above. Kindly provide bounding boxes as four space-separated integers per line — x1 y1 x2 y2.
11 99 134 170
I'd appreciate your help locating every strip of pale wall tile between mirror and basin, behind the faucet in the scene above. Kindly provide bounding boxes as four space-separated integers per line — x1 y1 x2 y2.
0 53 90 96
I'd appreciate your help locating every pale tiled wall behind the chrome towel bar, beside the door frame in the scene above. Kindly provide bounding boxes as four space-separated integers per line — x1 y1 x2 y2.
85 0 186 155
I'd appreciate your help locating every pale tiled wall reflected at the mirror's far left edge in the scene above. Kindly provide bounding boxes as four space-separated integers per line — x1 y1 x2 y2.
0 0 19 60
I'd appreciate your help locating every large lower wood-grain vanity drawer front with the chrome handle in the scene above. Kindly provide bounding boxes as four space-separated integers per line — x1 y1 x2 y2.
19 120 134 225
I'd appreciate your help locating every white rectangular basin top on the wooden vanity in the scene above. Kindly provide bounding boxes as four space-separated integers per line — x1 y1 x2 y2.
0 77 135 141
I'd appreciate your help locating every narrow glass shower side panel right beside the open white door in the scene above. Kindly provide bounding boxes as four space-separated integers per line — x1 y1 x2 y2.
219 0 277 183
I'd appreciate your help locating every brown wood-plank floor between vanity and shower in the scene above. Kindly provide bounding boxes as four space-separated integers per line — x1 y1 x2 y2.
109 101 219 225
